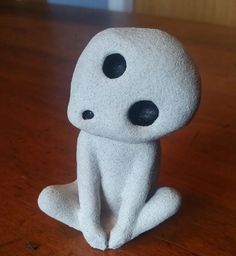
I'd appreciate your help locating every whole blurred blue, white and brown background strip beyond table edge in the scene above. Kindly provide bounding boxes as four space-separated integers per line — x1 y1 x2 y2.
29 0 236 27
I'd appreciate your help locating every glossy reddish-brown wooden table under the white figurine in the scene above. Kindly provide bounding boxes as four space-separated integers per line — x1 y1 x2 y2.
0 1 236 256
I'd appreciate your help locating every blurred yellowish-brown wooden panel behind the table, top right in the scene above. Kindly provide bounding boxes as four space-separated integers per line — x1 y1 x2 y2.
134 0 236 27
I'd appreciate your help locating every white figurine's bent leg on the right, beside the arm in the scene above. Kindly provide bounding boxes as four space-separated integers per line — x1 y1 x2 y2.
132 187 180 239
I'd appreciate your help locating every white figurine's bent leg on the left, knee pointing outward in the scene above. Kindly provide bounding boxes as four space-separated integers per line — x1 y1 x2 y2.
38 181 80 230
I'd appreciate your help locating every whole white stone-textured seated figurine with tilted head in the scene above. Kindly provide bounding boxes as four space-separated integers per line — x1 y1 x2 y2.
38 28 200 250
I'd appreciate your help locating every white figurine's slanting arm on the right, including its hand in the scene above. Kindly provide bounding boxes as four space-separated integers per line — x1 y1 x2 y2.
109 142 159 248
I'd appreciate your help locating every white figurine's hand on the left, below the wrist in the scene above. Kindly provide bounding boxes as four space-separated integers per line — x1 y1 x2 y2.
82 225 108 250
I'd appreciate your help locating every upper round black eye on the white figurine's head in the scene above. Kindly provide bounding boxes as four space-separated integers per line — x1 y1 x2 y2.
102 53 126 79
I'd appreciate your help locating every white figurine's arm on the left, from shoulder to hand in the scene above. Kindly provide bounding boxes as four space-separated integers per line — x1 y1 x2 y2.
77 132 107 250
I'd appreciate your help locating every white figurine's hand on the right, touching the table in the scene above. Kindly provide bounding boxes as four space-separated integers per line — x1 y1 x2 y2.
108 225 132 249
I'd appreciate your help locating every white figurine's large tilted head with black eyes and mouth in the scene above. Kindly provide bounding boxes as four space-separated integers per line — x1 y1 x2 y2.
68 28 200 143
